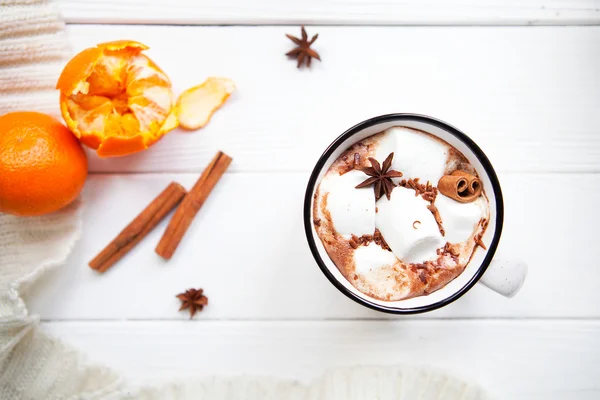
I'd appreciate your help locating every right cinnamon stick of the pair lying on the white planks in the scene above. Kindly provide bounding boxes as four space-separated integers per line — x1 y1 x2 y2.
156 151 231 260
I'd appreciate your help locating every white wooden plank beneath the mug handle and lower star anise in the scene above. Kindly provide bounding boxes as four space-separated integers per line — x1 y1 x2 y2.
24 173 600 320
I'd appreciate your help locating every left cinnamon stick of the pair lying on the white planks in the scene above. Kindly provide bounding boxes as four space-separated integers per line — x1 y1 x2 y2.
89 182 187 272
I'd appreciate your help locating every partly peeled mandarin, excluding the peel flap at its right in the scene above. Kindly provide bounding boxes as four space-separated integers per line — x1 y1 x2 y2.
56 40 178 157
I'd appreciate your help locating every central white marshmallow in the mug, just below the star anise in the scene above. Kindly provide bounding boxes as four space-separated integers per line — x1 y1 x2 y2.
375 187 446 263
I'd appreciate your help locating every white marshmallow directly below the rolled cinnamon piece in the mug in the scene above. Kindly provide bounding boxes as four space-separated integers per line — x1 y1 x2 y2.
435 193 487 243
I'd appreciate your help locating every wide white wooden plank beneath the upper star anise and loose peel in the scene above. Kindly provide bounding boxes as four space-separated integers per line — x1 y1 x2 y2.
59 26 600 172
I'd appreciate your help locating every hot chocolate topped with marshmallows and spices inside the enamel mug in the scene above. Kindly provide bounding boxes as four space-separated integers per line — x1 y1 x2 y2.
313 126 490 301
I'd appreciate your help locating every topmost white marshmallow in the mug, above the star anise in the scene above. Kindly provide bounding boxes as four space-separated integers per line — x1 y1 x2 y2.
375 126 449 186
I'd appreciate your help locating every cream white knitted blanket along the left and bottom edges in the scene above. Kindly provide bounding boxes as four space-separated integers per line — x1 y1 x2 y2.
0 0 489 400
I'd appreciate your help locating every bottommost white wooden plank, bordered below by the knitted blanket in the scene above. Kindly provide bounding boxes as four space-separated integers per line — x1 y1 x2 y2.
43 318 600 400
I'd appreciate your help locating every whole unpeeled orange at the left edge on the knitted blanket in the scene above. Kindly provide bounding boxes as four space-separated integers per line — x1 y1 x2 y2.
0 112 87 216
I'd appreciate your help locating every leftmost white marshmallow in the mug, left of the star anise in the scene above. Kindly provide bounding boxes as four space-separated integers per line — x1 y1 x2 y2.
319 171 375 236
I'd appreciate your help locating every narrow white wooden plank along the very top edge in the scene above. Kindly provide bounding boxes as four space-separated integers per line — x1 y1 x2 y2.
58 0 600 25
